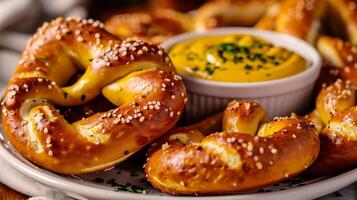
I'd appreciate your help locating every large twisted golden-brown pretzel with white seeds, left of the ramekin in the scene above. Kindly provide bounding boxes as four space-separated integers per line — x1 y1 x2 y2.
2 18 187 174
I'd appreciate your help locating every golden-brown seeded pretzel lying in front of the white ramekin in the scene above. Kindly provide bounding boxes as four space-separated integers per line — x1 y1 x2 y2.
145 101 319 195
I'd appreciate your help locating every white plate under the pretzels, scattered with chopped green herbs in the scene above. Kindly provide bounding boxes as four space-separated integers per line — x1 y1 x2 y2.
0 125 357 200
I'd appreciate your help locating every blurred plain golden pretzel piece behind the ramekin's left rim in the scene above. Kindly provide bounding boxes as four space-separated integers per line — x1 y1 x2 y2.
195 0 278 31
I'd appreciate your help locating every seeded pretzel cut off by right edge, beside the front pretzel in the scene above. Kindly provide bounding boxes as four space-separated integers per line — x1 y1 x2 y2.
308 80 357 175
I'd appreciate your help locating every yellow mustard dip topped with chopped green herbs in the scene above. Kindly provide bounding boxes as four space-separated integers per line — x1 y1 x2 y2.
169 34 308 82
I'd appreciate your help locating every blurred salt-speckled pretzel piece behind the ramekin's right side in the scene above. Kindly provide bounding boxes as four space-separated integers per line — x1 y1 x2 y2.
255 0 325 44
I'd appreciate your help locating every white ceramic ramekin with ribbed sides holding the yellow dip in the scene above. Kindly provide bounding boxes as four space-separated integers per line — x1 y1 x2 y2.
161 27 321 121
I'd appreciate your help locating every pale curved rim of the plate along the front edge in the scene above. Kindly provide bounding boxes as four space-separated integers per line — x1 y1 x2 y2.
0 132 357 200
